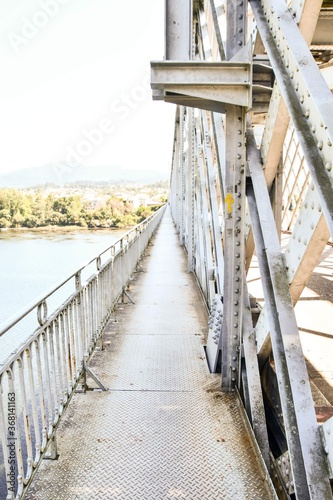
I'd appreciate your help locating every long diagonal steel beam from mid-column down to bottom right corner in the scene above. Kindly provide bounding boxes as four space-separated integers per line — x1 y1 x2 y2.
248 130 331 500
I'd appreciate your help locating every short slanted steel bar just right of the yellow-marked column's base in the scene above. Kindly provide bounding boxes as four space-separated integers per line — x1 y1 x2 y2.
243 277 270 470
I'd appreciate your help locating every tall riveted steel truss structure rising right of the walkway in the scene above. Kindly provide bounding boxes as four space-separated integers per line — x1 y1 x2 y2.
151 0 333 499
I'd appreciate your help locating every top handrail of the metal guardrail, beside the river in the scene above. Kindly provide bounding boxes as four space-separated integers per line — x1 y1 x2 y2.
0 205 164 337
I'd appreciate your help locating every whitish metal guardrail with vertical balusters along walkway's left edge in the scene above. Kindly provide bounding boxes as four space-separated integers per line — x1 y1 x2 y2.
0 206 165 500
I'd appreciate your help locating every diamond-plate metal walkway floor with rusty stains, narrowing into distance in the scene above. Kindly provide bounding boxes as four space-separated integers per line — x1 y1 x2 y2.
26 211 274 500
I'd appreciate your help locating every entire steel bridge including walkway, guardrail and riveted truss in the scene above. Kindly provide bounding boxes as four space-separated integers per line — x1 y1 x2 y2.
0 0 333 500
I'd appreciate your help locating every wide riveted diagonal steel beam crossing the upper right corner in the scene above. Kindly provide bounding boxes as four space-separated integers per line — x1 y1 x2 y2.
251 0 333 235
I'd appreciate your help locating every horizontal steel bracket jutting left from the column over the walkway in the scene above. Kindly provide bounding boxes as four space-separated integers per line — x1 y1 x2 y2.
151 61 252 113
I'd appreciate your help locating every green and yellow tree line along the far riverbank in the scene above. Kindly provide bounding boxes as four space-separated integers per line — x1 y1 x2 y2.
0 189 158 228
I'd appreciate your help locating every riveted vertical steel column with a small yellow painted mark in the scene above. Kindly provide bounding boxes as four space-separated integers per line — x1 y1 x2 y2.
222 0 247 392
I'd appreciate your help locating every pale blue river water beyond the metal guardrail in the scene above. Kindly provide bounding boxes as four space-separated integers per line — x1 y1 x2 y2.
0 229 126 365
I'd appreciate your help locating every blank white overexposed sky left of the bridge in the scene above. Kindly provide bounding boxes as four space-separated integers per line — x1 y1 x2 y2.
0 0 175 173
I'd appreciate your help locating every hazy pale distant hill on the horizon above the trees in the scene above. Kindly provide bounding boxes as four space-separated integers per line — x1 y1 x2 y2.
0 162 168 188
